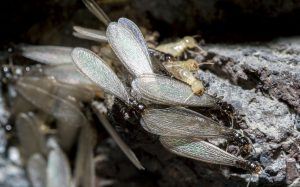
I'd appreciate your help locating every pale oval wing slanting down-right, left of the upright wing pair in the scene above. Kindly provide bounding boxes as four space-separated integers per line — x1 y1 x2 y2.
72 48 129 102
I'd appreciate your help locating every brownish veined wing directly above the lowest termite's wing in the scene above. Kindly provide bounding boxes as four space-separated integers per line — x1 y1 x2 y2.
142 107 231 138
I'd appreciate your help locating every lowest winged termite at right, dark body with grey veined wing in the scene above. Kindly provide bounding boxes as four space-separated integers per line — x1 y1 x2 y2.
160 136 262 174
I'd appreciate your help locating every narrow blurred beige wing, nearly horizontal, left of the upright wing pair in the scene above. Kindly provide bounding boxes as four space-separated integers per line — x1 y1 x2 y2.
73 26 107 42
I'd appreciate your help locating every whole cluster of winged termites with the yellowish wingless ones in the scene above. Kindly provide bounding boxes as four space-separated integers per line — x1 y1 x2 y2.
0 0 261 186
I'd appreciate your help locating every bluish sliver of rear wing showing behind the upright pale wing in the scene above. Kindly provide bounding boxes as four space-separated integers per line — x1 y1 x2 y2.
118 18 151 62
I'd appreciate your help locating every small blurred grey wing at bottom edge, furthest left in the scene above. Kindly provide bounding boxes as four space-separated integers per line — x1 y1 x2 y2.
26 153 47 187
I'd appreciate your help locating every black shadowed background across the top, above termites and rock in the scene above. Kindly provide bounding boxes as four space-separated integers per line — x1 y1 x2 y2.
0 0 300 46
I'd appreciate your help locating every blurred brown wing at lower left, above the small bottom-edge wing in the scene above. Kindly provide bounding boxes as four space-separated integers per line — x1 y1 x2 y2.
16 113 47 160
